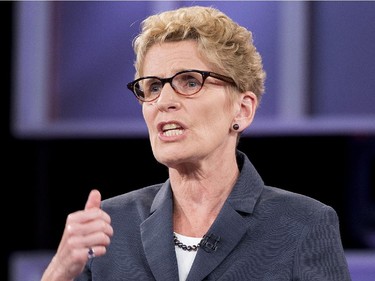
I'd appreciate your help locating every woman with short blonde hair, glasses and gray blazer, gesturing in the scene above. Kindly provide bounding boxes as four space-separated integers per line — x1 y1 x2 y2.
42 6 350 281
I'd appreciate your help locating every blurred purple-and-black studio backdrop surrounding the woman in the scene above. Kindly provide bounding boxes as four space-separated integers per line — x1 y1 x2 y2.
0 1 375 281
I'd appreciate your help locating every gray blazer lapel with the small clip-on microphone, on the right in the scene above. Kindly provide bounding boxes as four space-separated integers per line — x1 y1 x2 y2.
187 152 264 281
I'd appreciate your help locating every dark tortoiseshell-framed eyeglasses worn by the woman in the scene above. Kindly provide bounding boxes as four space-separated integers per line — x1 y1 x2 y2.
127 69 235 102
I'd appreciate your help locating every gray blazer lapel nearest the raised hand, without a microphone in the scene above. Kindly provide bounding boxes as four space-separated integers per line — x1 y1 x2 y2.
140 181 178 281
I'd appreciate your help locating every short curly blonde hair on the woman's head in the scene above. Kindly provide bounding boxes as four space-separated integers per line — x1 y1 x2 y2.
133 6 266 104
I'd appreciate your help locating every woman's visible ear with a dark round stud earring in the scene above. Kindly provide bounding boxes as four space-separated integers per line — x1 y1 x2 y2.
233 91 258 131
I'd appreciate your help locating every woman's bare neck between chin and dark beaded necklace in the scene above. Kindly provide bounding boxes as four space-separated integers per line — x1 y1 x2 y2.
170 155 239 237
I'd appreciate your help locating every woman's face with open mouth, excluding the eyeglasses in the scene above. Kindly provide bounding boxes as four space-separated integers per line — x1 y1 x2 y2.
142 41 238 168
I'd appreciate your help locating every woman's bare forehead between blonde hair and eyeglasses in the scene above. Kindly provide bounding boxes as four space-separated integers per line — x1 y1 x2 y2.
143 40 210 77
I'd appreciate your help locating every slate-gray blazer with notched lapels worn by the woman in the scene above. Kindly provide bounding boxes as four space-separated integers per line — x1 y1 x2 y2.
76 151 351 281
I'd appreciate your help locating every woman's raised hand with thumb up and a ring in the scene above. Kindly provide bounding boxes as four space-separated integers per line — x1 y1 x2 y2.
41 189 113 281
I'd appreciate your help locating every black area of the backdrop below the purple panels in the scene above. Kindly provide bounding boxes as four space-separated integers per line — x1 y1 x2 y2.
0 1 375 280
